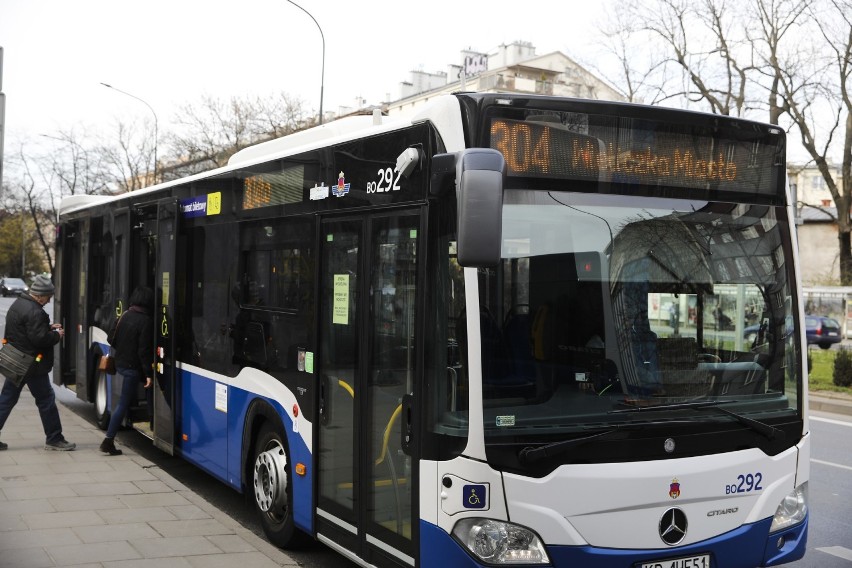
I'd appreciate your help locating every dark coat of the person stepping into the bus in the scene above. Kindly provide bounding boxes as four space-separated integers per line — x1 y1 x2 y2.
108 306 154 378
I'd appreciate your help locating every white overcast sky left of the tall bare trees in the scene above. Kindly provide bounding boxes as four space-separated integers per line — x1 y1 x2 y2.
0 0 602 146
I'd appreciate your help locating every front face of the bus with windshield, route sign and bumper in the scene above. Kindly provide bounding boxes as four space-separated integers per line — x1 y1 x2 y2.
421 96 810 568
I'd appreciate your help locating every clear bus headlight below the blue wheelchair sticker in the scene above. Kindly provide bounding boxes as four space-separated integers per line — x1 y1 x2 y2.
453 518 550 564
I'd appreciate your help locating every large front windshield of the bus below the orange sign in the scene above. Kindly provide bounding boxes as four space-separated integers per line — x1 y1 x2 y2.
479 190 802 467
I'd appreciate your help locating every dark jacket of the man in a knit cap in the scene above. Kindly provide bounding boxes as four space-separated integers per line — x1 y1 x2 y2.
5 294 61 376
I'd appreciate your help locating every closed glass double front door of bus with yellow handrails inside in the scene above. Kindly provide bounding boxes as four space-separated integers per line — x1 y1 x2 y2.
315 210 423 566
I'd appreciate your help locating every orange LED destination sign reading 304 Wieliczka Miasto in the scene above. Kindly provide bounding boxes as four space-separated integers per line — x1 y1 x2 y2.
490 115 778 193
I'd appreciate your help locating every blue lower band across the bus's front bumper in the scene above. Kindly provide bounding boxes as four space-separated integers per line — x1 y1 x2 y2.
420 517 808 568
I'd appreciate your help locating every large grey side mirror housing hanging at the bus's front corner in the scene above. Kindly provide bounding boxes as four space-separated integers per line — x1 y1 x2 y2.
456 148 506 268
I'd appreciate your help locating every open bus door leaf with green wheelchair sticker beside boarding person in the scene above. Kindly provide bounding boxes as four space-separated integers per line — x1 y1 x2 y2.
152 198 179 454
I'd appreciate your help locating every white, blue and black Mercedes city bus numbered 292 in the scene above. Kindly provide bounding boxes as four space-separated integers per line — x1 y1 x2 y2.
54 93 810 568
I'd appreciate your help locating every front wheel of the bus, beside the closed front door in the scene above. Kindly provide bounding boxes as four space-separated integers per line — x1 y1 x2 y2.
251 421 309 549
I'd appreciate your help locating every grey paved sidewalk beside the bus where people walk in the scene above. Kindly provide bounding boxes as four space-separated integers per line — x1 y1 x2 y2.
0 392 299 568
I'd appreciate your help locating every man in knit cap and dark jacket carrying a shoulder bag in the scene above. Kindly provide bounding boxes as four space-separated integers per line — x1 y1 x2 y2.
0 275 77 451
